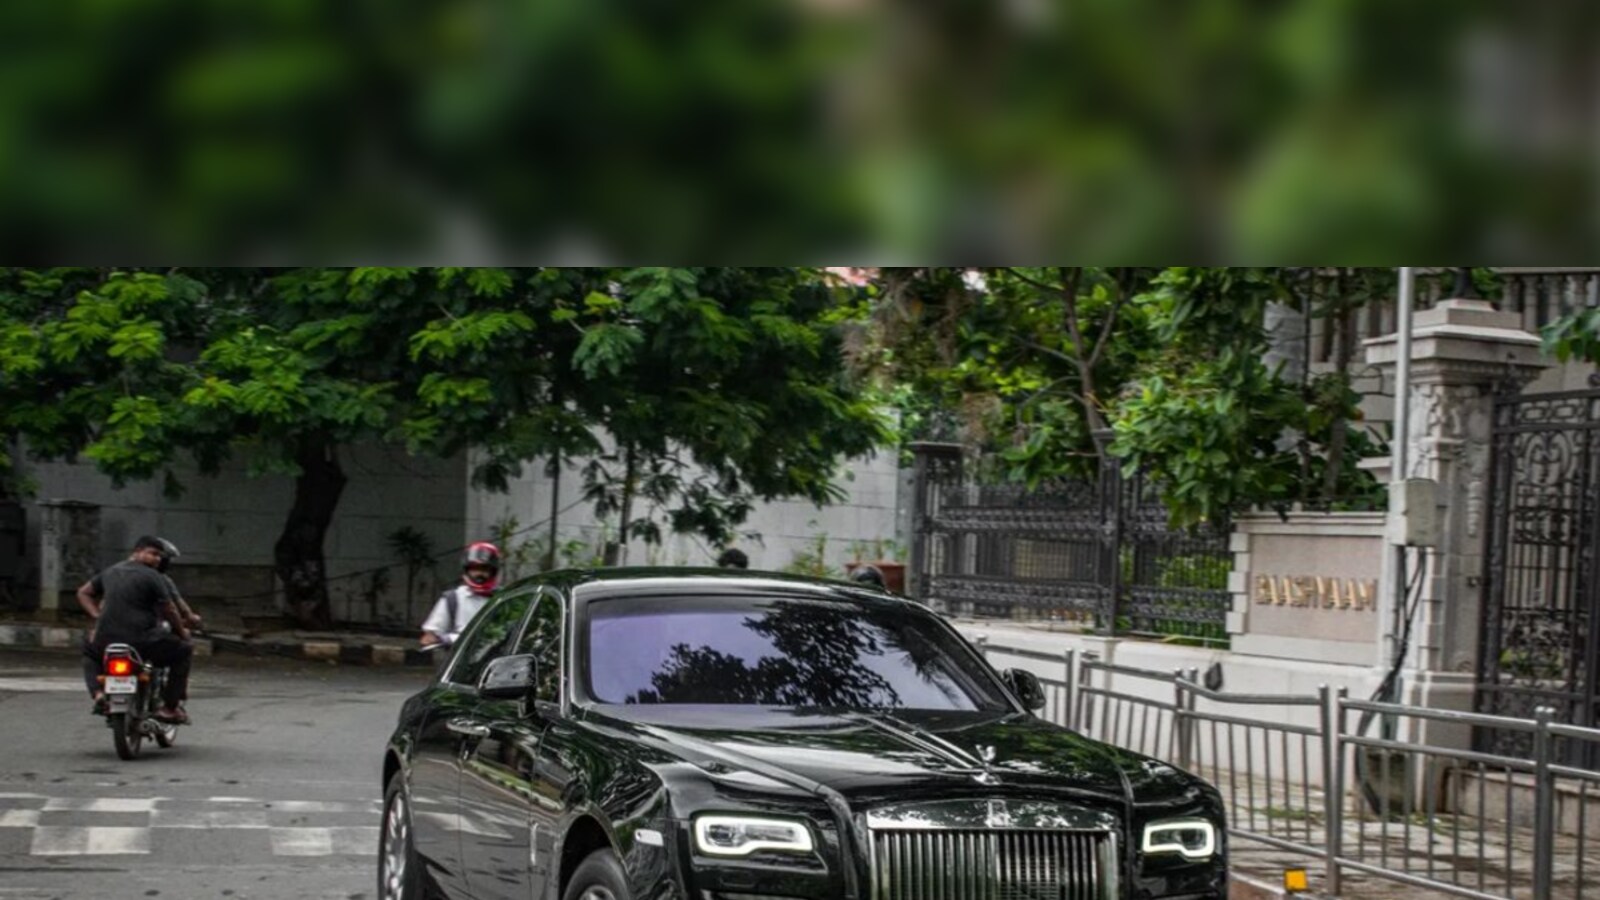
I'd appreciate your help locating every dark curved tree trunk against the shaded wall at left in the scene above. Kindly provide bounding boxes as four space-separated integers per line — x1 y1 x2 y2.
272 439 349 628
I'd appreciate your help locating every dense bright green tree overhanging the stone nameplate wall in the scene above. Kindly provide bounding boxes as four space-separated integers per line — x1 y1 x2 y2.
1112 267 1381 525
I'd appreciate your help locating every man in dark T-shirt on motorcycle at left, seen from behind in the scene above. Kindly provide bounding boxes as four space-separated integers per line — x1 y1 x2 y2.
78 535 194 724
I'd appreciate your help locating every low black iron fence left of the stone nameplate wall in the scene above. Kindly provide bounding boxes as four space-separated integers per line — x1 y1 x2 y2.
910 444 1234 644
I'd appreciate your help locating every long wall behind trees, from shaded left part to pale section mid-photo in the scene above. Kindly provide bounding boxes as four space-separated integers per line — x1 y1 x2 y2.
19 435 909 625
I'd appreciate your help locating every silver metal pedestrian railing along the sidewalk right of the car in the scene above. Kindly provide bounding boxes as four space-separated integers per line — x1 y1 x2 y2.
978 639 1600 900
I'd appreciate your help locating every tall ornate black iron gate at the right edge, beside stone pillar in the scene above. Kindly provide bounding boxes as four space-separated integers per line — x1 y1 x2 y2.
1477 391 1600 754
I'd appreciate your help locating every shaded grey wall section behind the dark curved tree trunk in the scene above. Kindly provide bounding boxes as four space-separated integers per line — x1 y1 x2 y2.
14 447 466 621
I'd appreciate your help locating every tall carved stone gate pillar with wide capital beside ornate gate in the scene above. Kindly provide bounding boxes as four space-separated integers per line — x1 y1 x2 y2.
1366 299 1549 698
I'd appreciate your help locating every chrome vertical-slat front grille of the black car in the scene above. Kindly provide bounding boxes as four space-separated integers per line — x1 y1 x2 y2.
872 828 1117 900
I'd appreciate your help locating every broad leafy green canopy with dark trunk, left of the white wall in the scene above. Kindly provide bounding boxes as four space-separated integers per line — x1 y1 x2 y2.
0 267 882 623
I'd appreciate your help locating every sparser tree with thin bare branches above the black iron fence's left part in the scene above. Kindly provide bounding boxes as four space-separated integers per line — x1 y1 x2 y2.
869 267 1154 482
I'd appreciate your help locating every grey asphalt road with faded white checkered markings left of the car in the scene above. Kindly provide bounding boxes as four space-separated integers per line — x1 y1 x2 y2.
0 650 427 900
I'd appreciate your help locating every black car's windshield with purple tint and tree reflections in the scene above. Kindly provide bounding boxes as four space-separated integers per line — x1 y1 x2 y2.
584 597 1006 709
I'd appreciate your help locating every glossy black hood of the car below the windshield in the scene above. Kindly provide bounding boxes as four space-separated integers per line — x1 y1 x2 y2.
592 708 1128 801
